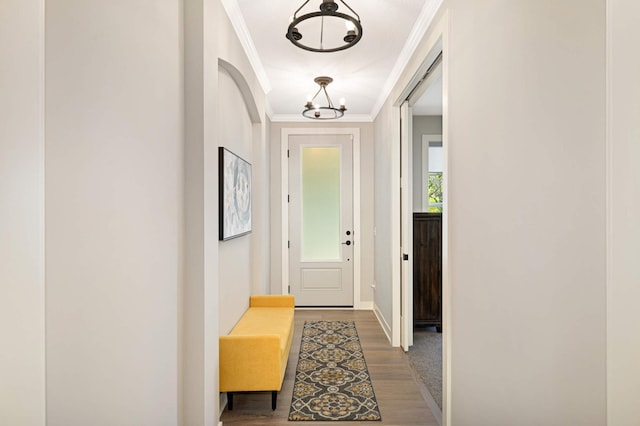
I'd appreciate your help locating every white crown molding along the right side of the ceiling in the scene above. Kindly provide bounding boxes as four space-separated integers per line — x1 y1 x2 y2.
370 0 443 118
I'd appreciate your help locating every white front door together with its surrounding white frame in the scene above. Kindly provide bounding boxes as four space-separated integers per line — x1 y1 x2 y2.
281 128 362 309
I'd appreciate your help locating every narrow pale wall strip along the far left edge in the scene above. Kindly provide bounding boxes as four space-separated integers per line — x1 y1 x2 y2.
0 0 45 426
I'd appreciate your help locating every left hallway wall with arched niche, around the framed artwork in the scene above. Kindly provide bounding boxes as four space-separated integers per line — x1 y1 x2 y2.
216 2 269 334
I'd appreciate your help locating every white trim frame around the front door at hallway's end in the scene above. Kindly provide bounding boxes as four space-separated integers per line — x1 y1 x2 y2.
280 127 364 309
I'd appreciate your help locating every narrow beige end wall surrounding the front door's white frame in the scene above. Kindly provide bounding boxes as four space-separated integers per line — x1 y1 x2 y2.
269 122 374 305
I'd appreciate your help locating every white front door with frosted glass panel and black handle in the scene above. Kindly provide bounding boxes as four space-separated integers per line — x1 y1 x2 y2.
289 135 356 307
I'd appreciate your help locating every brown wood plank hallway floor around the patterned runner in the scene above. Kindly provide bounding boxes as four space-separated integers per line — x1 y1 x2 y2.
221 310 438 426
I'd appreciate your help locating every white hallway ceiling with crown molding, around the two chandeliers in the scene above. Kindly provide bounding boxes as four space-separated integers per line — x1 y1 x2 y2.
222 0 442 121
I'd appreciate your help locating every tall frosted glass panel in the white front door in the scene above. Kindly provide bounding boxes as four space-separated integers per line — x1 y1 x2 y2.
301 146 341 260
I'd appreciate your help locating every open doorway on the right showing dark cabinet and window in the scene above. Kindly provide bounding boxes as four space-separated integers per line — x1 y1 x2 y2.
397 36 448 419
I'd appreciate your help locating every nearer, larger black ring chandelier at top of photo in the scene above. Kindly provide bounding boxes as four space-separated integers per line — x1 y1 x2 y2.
286 0 362 52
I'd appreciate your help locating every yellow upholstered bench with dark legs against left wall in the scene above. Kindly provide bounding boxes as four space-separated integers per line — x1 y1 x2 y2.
220 295 295 410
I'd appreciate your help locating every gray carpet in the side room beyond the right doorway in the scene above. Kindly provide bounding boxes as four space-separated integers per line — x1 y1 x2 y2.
408 327 442 409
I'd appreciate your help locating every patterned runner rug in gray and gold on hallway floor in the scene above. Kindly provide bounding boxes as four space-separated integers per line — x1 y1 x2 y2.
289 321 381 421
